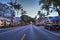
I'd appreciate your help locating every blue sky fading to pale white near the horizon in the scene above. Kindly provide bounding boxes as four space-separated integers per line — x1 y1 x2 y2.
0 0 58 17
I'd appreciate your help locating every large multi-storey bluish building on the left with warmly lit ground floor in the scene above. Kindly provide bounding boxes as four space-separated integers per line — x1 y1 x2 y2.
0 3 15 26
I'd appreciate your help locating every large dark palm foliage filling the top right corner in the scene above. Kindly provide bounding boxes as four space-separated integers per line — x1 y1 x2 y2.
39 0 60 16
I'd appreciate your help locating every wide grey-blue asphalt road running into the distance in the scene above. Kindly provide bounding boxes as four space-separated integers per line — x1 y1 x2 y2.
0 25 60 40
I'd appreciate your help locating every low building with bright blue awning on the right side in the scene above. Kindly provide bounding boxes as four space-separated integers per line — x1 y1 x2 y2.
39 16 60 25
